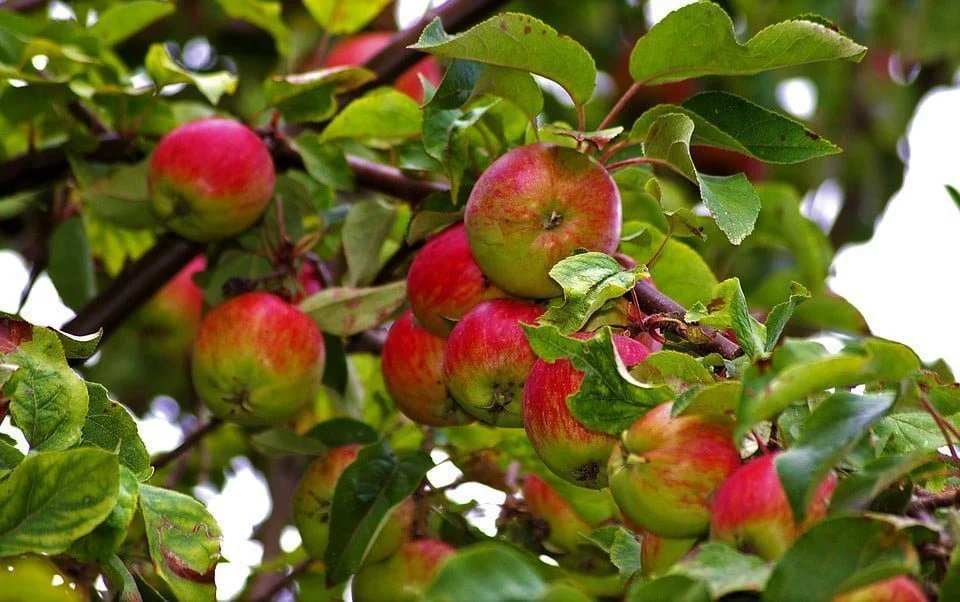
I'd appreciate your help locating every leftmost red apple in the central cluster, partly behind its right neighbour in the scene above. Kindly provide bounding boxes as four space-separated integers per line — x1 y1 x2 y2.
380 311 472 426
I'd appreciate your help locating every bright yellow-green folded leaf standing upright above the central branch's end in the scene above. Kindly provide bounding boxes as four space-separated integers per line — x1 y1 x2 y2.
686 278 767 358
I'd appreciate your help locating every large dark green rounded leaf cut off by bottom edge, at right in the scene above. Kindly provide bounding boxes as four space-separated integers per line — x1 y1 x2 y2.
763 516 917 602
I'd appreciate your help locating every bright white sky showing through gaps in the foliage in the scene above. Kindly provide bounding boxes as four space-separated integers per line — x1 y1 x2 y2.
0 0 960 599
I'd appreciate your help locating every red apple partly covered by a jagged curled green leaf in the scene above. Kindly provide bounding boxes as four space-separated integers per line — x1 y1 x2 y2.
523 334 650 489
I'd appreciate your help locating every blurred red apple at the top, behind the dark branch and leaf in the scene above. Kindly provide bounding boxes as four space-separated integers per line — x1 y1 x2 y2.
303 31 443 102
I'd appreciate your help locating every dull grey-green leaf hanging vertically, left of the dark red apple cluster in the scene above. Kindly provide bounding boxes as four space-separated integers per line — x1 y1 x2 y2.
341 199 397 286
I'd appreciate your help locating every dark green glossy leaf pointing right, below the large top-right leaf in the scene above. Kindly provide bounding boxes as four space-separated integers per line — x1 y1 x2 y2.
630 92 841 163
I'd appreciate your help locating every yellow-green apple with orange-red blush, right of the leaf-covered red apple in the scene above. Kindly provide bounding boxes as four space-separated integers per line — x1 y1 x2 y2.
607 402 740 539
